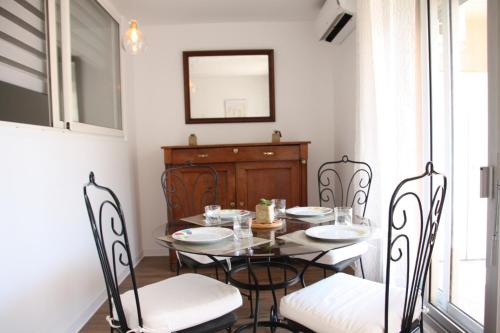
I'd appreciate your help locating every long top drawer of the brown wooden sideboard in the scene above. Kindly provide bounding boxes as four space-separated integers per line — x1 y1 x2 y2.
172 145 300 164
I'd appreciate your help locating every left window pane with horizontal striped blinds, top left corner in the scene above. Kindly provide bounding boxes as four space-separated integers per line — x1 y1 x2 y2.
0 0 51 126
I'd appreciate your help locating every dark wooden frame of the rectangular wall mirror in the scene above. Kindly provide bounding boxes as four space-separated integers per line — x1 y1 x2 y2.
182 49 275 124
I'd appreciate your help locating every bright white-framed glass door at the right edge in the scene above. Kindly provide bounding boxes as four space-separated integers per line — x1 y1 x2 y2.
426 0 498 332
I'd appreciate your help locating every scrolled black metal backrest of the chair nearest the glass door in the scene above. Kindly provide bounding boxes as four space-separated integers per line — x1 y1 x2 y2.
385 162 447 332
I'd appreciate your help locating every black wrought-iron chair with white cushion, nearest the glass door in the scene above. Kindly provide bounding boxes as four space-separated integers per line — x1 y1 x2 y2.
280 162 447 333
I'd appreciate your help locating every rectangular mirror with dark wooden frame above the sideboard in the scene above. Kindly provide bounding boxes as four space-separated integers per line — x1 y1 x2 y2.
183 50 275 124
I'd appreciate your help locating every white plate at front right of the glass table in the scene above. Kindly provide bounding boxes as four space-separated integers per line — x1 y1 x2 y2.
306 225 370 242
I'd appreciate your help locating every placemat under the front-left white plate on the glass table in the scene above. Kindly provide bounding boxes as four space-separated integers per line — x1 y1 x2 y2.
157 236 271 256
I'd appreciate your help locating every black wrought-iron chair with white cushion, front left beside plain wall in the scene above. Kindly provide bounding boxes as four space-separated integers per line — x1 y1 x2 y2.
83 172 242 333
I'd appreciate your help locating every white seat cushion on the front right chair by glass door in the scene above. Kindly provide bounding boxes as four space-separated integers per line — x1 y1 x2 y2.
280 273 422 333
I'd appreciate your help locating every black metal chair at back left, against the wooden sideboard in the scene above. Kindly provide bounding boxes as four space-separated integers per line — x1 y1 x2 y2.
161 163 230 279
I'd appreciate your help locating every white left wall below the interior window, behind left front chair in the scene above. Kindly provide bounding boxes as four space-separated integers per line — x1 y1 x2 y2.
0 60 142 332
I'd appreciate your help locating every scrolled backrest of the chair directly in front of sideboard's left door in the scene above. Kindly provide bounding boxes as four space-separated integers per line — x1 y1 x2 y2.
161 163 218 221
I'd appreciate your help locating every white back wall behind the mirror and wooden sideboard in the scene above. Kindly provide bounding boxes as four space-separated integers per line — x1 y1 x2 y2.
134 22 336 255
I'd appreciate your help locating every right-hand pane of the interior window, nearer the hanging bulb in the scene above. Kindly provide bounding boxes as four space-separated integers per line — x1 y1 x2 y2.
70 0 122 129
